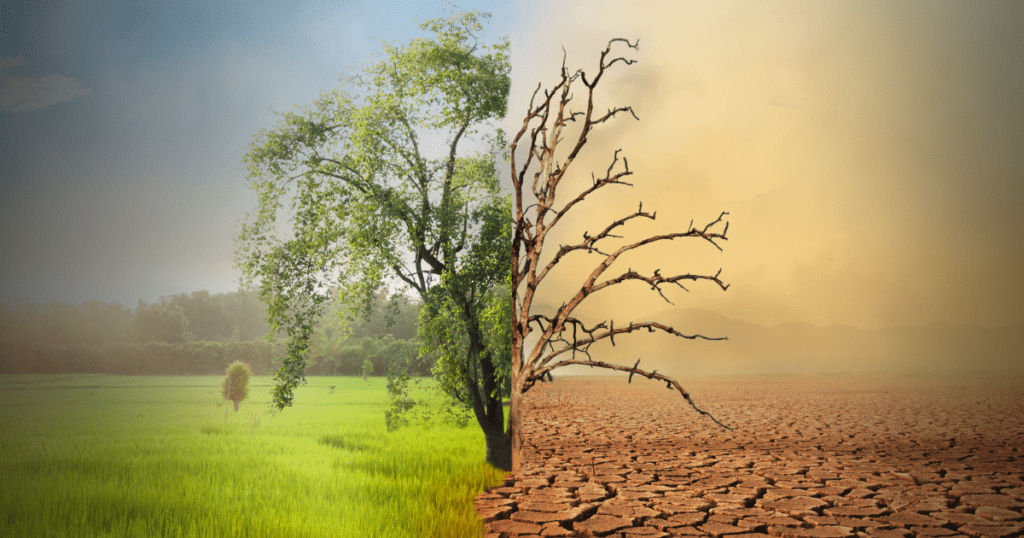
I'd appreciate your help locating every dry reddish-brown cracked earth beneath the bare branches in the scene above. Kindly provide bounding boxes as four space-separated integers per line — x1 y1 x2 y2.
476 376 1024 538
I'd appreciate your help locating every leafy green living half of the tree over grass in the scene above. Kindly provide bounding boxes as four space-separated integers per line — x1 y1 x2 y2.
237 11 512 468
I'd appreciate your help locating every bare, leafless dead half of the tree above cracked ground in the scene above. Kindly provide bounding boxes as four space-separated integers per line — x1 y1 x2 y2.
509 39 729 469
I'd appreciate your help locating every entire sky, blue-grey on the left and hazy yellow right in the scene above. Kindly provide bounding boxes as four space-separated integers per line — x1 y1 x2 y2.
0 0 1024 328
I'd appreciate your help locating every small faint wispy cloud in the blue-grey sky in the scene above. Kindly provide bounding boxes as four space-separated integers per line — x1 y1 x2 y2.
0 55 90 112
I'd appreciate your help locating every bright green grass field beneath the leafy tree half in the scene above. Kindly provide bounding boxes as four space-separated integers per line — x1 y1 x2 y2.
0 375 507 538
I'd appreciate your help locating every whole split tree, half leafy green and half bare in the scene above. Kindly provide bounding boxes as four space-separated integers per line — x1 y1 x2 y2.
236 11 728 469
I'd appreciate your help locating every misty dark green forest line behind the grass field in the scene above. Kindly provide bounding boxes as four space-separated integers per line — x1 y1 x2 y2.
0 290 425 375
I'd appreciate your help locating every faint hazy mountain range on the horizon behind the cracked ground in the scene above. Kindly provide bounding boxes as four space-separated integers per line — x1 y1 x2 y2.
534 304 1024 376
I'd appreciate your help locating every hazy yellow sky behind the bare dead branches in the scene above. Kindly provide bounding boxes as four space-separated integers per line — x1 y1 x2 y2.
505 1 1024 329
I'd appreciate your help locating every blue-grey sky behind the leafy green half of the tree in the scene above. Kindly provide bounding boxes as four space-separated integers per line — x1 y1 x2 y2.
0 1 513 306
